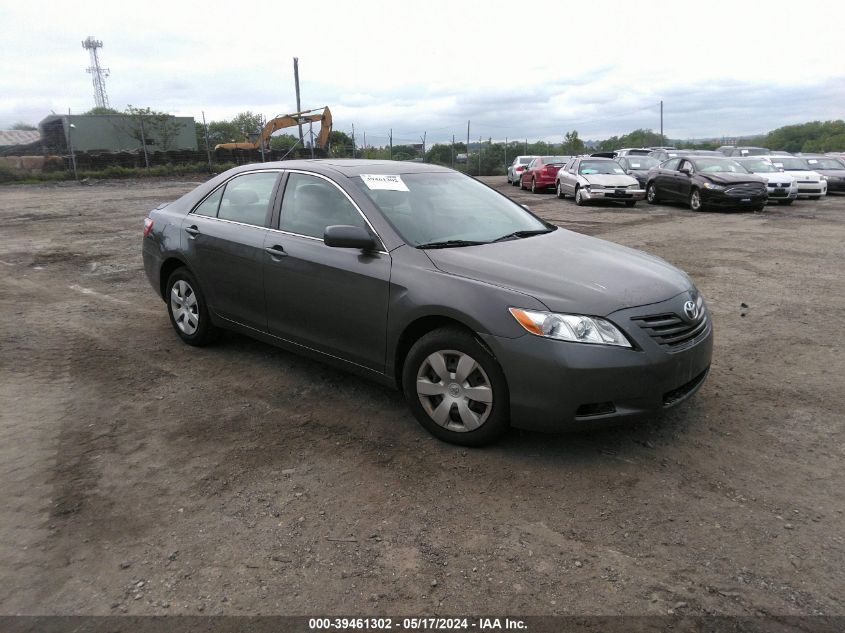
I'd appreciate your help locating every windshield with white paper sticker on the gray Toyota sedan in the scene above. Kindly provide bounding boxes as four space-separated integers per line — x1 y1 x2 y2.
351 172 555 246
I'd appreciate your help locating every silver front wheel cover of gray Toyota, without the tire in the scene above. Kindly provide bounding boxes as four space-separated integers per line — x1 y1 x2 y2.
416 350 493 433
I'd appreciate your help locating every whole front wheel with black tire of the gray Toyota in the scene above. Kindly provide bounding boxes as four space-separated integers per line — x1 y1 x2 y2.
402 327 510 446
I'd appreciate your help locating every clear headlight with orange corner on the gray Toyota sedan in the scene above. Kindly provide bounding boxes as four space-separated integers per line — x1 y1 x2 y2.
509 308 631 347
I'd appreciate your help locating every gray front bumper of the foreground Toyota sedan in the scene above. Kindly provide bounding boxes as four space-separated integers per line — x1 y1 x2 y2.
479 293 713 431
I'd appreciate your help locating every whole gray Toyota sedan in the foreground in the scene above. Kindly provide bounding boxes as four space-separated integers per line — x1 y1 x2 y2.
143 159 713 445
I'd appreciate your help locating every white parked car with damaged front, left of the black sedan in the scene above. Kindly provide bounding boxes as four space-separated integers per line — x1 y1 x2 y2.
555 157 645 207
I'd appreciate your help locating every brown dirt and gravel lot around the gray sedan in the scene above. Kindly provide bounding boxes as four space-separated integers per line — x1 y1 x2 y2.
0 177 845 615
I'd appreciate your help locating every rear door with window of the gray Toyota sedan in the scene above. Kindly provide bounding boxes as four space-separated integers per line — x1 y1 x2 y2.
182 170 281 332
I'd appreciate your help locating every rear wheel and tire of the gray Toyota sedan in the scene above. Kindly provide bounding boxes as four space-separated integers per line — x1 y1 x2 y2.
165 268 216 347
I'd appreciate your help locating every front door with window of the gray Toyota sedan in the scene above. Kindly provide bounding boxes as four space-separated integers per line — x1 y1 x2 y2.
263 171 391 372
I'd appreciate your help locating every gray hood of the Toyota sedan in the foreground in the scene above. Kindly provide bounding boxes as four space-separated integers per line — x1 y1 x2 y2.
425 229 692 316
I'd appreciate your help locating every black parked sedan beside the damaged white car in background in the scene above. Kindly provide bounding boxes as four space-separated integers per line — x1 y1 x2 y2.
646 156 768 211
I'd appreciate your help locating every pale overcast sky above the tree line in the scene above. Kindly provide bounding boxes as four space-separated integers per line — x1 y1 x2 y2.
0 0 845 144
